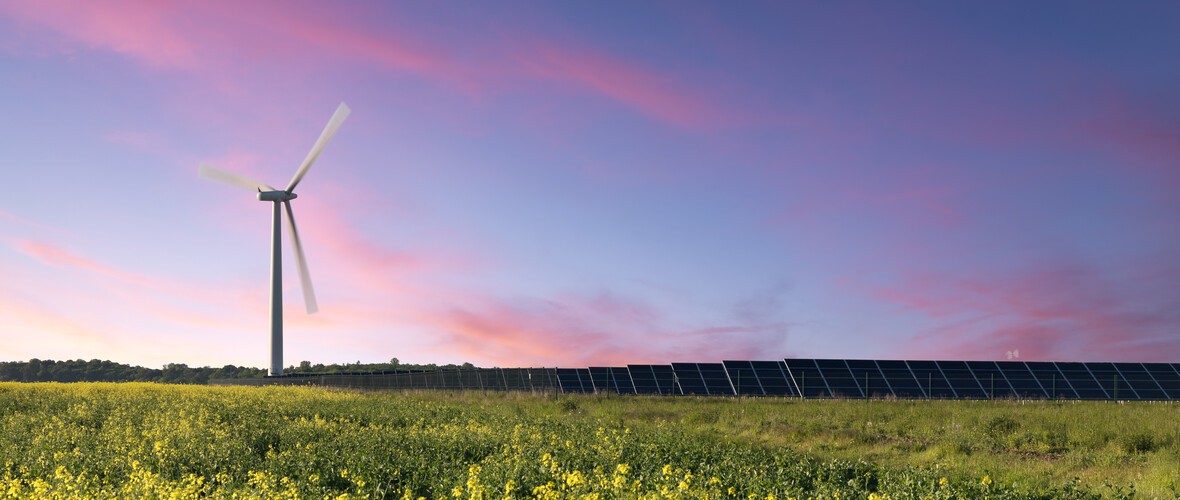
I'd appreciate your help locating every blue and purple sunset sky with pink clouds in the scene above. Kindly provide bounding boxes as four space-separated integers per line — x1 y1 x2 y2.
0 0 1180 367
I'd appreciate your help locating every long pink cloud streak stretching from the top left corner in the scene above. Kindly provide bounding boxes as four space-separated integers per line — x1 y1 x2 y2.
0 0 736 132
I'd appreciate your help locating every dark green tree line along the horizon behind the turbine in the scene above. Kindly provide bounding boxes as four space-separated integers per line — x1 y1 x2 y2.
0 357 476 384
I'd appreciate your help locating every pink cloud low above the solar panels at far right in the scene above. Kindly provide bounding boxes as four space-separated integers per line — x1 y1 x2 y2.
873 262 1180 361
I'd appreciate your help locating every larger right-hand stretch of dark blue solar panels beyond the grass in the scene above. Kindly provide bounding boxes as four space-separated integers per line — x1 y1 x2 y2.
557 358 1180 401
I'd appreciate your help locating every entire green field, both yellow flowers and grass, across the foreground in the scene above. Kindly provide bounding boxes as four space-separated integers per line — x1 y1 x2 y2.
0 383 1180 499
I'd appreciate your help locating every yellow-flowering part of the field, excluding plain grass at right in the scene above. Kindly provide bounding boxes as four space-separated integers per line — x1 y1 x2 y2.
0 383 1165 499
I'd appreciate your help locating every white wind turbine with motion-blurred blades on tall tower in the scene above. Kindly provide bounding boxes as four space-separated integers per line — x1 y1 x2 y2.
197 103 352 376
